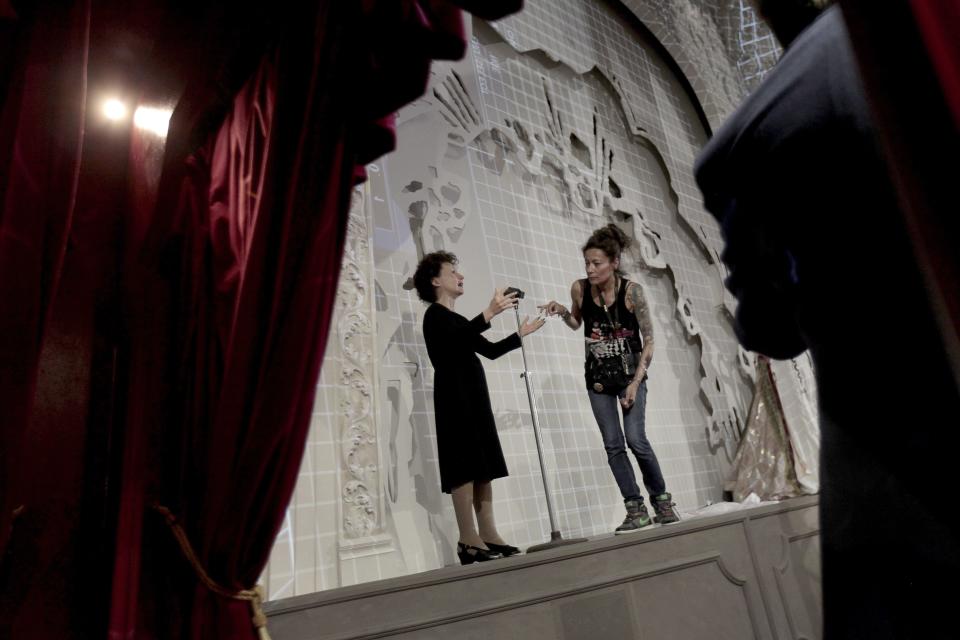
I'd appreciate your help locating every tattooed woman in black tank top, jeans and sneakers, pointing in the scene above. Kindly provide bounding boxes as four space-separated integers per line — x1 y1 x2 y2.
540 224 680 534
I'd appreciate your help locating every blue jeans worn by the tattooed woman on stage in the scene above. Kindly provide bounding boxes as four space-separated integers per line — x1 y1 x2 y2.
587 380 667 500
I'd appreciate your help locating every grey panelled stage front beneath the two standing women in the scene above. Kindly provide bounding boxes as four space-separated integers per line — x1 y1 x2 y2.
265 496 821 640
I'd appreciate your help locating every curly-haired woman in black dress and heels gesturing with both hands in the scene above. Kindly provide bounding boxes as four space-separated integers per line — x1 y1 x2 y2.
413 251 544 564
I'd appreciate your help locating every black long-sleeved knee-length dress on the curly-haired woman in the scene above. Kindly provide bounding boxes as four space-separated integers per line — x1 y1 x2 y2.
423 303 520 493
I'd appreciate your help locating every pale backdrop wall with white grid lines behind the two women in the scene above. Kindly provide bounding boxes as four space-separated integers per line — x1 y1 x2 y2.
265 0 788 598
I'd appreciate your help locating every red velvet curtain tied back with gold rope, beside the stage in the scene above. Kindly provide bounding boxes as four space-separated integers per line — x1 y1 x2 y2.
110 0 519 638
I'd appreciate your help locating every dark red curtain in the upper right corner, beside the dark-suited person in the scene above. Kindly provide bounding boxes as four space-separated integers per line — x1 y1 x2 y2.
841 0 960 389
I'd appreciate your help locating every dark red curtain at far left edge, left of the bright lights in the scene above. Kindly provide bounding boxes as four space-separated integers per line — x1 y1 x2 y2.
0 2 90 564
